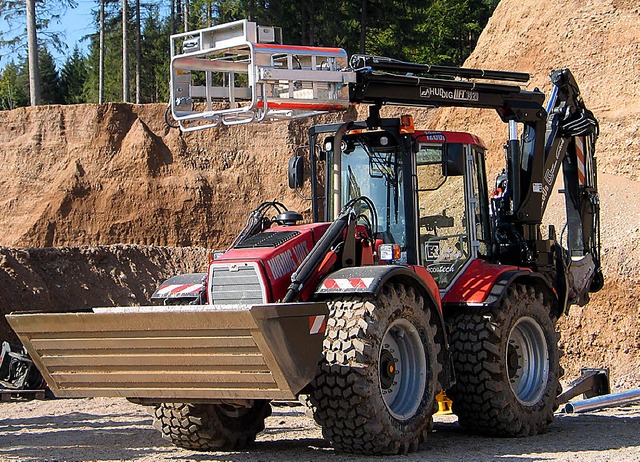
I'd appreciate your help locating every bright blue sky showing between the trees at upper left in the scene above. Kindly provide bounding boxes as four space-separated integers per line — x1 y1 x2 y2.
0 0 98 69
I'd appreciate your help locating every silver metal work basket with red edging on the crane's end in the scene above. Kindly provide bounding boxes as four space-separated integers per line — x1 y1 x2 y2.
170 20 355 131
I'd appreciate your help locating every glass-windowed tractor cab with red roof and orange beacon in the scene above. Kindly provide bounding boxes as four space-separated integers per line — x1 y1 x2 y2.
291 116 490 291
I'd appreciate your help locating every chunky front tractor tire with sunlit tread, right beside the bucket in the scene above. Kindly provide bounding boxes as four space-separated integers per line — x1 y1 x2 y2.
310 284 441 454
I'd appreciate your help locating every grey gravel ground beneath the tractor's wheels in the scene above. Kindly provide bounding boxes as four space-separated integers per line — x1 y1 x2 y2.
0 398 640 462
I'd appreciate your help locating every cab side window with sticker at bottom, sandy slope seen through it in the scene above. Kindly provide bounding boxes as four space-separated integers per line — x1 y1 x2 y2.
416 144 470 289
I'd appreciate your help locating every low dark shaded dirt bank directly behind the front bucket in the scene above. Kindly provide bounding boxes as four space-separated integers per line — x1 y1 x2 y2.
0 245 207 342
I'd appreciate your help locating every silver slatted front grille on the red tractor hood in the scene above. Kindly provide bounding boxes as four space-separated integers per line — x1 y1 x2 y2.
209 263 266 305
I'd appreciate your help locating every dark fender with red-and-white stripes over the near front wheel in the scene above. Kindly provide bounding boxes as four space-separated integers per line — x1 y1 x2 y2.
315 265 455 389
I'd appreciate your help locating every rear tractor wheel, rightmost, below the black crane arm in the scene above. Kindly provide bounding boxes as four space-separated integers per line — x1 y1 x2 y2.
447 284 562 436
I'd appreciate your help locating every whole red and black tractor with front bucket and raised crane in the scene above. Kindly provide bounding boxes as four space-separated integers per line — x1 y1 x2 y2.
8 22 603 454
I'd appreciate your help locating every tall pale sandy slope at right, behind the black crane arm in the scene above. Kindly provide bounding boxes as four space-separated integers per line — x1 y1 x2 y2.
429 0 640 388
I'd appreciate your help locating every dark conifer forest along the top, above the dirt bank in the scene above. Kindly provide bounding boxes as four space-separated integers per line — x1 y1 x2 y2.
0 0 498 103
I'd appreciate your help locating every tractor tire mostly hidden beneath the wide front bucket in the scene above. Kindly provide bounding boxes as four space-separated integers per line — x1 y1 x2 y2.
153 400 271 451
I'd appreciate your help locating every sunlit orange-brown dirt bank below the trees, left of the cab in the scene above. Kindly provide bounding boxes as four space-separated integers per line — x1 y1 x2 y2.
0 104 350 247
